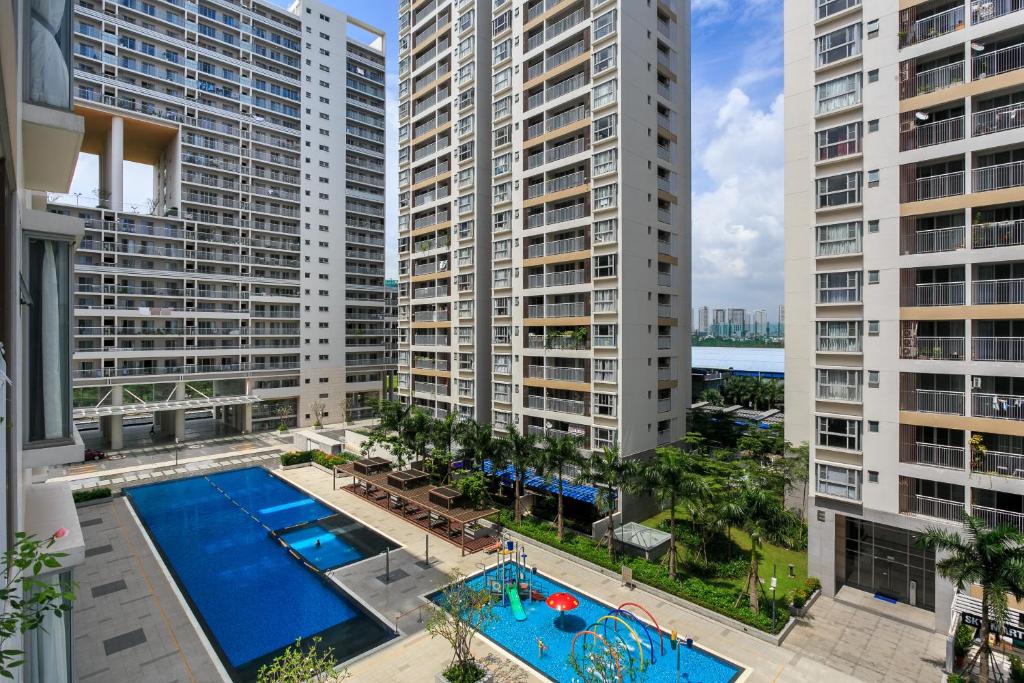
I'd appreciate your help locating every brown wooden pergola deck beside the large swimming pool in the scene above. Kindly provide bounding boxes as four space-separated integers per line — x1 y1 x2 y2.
334 460 498 555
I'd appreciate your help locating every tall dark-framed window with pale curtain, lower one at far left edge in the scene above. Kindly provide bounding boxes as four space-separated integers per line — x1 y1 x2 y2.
22 237 72 445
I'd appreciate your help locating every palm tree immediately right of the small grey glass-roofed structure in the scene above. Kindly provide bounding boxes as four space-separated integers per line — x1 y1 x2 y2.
632 445 711 579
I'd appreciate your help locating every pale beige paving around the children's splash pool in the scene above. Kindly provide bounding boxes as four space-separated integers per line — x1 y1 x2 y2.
281 468 945 683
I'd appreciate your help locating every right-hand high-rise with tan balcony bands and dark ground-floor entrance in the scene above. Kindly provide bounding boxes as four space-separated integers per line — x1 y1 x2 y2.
785 0 1024 629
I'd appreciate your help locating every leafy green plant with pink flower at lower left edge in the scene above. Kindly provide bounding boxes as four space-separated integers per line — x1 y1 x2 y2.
0 528 75 679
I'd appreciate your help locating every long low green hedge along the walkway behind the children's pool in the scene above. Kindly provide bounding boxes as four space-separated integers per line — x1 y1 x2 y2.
496 513 786 634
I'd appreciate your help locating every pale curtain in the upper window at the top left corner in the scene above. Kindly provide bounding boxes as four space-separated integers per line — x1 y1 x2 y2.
29 0 71 106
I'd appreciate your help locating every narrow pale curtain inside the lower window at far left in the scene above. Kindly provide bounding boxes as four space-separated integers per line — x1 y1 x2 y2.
38 242 63 439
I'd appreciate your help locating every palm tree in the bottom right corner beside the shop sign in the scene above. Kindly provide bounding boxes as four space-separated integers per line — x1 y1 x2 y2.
918 514 1024 683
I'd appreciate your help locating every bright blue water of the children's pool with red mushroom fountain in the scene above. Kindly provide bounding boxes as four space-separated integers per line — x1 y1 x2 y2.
431 569 743 683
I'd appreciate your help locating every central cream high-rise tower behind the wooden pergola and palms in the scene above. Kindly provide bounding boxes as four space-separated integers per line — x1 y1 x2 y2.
399 0 690 462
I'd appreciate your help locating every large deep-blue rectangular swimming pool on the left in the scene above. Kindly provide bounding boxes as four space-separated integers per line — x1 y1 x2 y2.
124 467 394 681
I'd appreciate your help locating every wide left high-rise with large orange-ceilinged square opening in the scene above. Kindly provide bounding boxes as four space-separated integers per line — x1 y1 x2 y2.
51 0 385 447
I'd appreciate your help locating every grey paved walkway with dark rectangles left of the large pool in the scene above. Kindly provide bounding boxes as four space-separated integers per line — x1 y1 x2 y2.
75 498 221 683
